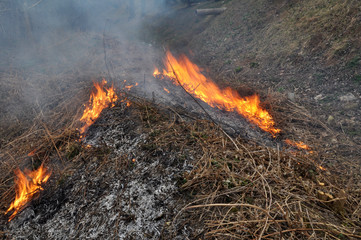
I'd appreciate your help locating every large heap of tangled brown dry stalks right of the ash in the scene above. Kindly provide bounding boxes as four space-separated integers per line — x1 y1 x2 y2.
159 122 361 239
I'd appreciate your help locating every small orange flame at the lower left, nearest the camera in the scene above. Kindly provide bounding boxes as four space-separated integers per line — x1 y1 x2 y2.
5 164 51 222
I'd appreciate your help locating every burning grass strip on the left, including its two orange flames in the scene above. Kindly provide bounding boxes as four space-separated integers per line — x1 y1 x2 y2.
0 74 138 221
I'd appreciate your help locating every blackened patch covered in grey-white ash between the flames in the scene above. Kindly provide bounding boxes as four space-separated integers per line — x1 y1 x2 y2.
3 104 200 239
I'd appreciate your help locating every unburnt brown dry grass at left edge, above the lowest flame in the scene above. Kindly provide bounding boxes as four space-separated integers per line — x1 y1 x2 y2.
0 104 79 215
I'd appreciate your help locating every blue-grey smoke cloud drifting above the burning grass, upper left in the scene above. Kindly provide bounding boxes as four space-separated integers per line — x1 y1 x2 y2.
0 0 180 141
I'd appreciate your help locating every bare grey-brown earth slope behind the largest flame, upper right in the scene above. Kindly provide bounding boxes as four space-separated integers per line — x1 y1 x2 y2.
144 0 361 161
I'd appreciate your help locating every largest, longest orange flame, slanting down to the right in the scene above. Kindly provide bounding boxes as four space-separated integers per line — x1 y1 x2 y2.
153 51 281 137
